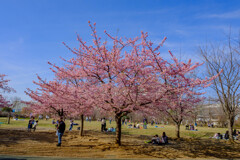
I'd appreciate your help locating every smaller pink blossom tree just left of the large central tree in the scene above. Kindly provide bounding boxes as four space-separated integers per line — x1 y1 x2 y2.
25 73 93 136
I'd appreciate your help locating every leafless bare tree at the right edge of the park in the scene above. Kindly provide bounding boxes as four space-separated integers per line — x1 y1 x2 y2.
200 35 240 141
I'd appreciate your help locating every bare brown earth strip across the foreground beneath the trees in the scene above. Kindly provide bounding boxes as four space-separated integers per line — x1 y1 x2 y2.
0 129 240 159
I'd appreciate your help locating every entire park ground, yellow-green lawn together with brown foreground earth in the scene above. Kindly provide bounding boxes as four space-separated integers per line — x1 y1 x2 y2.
0 118 240 159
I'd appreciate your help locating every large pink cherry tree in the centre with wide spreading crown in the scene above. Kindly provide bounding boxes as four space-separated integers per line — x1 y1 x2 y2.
27 22 221 145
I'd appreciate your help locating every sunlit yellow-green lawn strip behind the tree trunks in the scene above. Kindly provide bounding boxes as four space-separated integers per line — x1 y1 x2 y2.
0 117 227 138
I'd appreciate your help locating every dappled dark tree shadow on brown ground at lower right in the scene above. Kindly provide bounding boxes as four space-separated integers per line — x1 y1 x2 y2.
131 139 240 159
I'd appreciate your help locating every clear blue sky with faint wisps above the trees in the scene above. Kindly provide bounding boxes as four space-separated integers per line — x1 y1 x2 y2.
0 0 240 100
